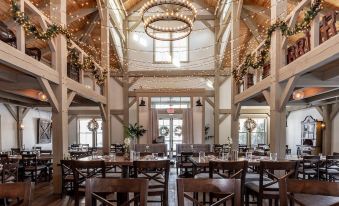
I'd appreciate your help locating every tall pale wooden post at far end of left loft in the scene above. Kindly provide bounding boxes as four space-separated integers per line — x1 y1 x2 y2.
101 0 111 154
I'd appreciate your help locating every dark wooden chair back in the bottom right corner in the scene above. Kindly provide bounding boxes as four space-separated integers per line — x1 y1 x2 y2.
279 178 339 206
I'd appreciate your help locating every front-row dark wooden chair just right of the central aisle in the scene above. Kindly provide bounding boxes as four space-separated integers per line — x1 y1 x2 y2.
177 178 241 206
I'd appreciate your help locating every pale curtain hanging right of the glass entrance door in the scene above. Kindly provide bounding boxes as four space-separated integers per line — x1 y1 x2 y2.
182 109 193 144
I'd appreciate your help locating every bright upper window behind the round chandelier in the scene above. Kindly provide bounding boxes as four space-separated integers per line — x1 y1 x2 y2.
154 33 188 63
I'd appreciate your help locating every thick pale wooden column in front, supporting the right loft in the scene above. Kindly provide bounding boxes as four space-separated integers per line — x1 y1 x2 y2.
270 0 287 158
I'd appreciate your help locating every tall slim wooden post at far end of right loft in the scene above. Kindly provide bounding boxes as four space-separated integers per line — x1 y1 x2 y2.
230 0 240 149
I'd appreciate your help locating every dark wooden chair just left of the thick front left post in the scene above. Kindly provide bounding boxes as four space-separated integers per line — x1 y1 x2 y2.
21 154 48 183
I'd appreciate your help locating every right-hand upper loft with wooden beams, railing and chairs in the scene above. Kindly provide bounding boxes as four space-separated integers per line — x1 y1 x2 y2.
235 0 339 108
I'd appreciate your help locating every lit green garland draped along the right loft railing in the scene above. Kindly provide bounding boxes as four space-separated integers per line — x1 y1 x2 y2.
232 0 323 82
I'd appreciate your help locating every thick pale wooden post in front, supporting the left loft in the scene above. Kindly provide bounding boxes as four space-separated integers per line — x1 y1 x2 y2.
50 0 68 193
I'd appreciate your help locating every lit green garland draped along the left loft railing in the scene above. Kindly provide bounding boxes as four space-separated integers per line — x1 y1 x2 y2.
11 0 108 86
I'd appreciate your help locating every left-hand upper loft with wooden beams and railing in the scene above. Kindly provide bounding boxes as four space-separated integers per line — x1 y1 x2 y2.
0 0 129 106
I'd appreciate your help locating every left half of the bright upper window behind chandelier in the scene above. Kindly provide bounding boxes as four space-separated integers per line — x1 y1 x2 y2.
154 33 171 62
